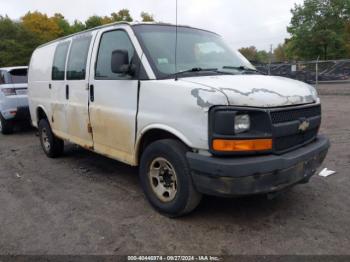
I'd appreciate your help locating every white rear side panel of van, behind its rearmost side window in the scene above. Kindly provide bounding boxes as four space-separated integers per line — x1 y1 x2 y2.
28 43 56 127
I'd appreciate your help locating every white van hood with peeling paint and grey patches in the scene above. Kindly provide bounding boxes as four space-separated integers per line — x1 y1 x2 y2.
181 75 318 107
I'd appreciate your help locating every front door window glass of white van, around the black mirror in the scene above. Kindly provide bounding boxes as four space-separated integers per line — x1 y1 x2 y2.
95 30 135 80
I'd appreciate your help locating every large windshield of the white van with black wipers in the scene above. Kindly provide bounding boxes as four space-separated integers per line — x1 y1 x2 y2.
133 25 256 78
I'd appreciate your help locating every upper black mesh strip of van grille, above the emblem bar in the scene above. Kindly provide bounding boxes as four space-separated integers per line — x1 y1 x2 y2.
271 105 321 124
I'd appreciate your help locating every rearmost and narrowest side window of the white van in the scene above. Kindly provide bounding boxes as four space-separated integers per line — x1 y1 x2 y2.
51 42 69 80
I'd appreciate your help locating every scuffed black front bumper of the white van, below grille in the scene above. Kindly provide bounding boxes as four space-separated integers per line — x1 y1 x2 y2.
187 136 330 197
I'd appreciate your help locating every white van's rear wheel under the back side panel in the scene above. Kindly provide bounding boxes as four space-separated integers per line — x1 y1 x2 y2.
38 119 64 158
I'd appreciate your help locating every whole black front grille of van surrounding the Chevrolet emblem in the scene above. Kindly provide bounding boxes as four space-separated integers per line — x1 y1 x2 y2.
270 105 321 153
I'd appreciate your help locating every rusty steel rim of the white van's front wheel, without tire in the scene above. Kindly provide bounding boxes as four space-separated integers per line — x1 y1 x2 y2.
148 157 177 203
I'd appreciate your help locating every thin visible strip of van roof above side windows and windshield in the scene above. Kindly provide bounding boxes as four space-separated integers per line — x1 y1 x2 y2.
37 21 216 48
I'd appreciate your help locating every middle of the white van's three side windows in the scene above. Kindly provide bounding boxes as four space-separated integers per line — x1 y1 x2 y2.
67 36 91 80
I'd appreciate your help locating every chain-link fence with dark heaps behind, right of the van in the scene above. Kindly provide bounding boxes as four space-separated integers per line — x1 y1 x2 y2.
255 59 350 85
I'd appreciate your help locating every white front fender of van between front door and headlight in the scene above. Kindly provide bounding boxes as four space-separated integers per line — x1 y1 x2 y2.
137 79 228 155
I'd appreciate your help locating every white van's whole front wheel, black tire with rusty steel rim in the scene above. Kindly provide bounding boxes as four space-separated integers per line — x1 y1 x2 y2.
139 139 202 217
